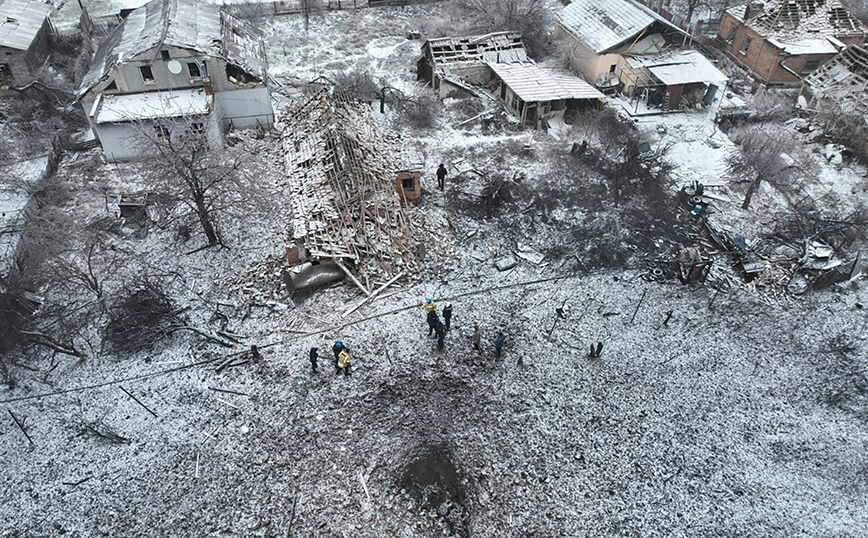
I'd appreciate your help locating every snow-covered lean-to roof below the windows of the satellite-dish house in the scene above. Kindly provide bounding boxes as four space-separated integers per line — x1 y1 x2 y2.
94 88 210 123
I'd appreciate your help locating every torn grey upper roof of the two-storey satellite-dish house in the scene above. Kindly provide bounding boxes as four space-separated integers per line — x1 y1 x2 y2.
78 0 267 96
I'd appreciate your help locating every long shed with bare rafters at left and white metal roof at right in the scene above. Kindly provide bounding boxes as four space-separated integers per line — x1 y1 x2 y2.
416 32 604 129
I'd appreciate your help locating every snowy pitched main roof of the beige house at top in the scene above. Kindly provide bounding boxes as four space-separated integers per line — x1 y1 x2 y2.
558 0 682 54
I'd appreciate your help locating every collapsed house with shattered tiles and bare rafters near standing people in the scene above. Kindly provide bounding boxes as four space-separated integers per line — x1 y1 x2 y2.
282 79 418 293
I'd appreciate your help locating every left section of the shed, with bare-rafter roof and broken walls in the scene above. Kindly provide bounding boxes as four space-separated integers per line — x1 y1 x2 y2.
416 32 528 99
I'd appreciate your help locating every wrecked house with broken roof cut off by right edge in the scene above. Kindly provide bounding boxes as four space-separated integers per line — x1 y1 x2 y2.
799 45 868 114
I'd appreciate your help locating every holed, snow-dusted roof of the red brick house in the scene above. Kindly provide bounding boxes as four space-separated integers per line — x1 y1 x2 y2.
727 0 868 41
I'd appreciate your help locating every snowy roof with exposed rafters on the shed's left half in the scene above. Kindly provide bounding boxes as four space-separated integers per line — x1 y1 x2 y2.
422 32 527 65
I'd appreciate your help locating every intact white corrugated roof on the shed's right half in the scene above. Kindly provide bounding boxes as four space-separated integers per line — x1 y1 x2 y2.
488 63 603 102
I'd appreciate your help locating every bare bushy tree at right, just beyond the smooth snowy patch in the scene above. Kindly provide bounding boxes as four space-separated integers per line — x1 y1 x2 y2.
727 124 810 209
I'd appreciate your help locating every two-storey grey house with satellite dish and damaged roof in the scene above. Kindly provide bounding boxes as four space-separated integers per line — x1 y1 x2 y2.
78 0 274 160
